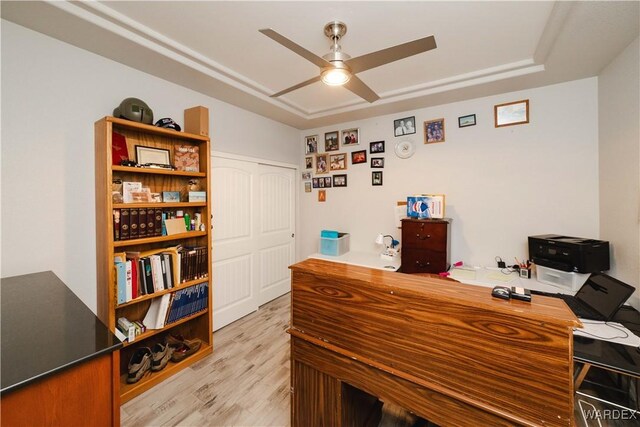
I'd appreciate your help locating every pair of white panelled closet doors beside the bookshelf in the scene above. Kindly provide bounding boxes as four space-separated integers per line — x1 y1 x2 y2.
211 156 296 330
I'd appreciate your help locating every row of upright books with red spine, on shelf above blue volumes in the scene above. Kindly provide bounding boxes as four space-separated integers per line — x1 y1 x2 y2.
114 246 209 304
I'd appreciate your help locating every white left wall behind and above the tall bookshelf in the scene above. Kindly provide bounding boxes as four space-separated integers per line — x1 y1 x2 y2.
1 20 300 311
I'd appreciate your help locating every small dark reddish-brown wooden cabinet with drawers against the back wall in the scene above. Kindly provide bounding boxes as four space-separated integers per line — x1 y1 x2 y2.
401 218 451 273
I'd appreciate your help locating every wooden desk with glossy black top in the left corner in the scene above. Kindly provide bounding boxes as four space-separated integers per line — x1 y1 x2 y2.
0 271 122 427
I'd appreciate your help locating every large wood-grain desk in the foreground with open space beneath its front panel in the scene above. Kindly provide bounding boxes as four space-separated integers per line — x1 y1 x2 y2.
290 259 580 426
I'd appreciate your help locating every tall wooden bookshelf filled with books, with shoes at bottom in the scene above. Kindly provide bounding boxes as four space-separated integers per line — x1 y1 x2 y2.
95 111 213 403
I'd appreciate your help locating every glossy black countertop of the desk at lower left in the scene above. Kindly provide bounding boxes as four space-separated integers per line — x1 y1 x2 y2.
0 271 122 394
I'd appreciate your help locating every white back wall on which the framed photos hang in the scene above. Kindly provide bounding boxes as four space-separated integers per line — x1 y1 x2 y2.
299 78 599 265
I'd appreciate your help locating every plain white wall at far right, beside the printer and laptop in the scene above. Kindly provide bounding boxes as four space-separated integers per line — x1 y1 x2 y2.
598 39 640 309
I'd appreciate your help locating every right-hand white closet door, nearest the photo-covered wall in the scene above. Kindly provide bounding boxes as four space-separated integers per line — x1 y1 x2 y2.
257 164 295 305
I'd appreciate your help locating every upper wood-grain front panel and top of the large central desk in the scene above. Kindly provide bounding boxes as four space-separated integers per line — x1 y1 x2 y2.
291 260 580 425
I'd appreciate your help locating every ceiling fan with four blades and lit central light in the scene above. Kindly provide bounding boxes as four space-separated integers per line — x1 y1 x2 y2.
259 21 437 102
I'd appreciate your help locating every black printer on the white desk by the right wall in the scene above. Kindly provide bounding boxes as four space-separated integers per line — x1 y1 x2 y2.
529 234 609 273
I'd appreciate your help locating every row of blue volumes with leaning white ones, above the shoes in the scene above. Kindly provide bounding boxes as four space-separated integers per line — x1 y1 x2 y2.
142 283 209 329
